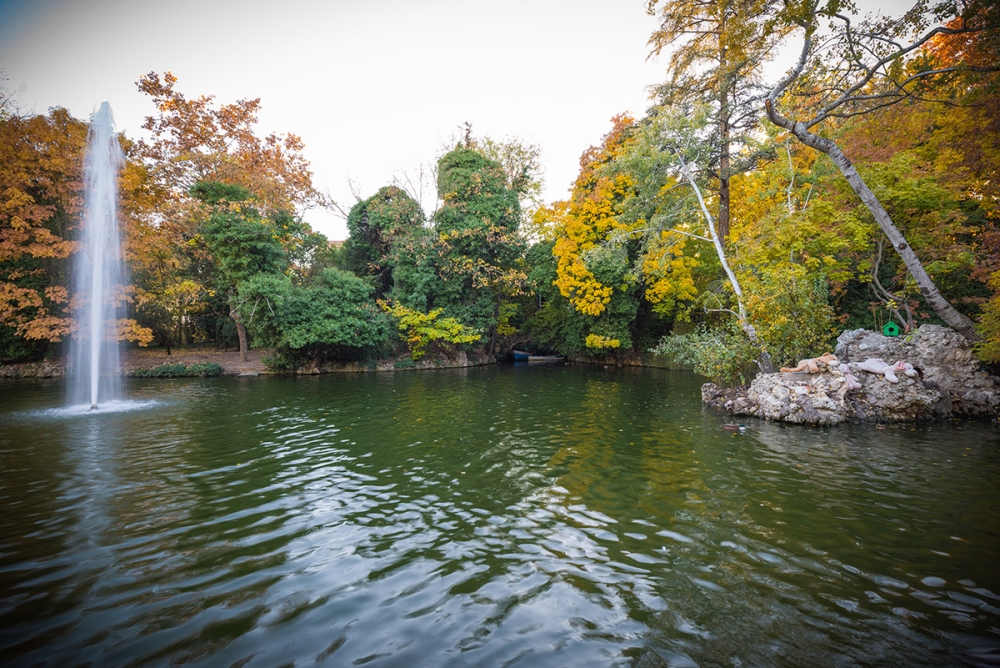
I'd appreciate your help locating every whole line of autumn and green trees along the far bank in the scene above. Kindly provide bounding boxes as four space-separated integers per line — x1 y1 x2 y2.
0 0 1000 382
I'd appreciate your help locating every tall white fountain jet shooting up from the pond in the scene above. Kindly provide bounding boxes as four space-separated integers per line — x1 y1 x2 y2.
69 102 127 410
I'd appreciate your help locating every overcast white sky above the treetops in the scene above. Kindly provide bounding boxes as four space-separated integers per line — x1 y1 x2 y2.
0 0 916 239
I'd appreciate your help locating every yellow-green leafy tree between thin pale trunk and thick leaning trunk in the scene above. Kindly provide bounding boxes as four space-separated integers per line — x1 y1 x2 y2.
727 136 848 366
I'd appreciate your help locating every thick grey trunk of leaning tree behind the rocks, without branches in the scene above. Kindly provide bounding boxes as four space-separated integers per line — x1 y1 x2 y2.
765 100 979 343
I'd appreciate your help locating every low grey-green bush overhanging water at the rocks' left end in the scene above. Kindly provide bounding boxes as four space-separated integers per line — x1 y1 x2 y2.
650 322 759 385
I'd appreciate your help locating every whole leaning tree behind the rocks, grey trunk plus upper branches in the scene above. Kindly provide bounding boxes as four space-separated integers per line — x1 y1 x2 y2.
765 0 995 341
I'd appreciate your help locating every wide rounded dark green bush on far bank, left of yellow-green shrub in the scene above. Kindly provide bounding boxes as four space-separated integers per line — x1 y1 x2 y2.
239 268 390 362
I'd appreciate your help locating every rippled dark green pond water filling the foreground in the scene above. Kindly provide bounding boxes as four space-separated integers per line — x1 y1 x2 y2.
0 366 1000 668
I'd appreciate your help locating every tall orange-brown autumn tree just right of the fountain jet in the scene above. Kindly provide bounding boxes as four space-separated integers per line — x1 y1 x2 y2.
131 72 327 350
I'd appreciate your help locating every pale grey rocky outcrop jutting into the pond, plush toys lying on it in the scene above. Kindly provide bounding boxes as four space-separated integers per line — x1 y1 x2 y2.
702 325 1000 425
